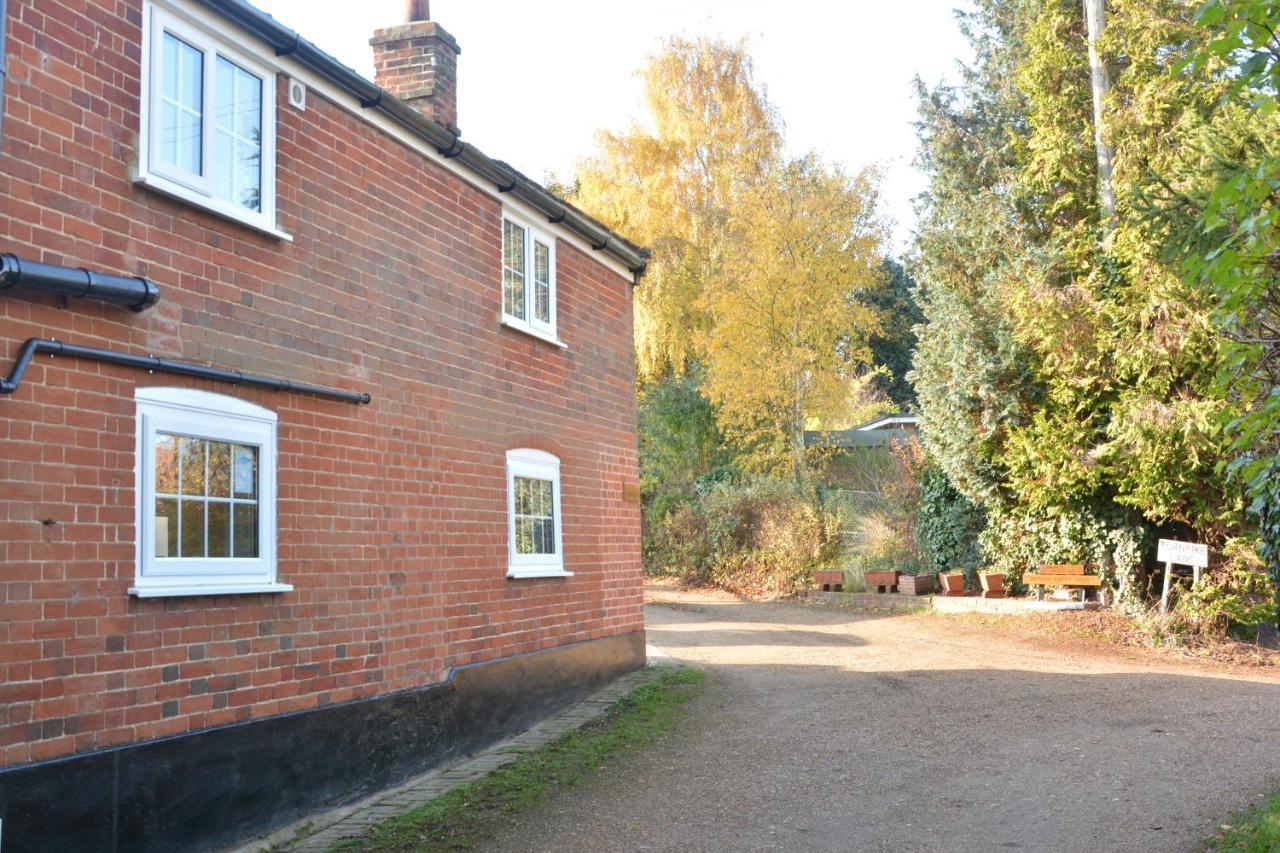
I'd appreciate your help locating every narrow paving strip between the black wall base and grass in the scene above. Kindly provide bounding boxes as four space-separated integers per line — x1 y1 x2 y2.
239 646 676 853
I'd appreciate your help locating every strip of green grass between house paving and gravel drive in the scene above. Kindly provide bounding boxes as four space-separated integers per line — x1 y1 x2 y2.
334 666 705 853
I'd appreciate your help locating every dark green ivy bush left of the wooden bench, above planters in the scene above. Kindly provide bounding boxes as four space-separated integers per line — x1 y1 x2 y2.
915 465 987 583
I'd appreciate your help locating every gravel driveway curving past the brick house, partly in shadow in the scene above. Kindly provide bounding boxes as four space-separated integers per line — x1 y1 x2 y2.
478 592 1280 853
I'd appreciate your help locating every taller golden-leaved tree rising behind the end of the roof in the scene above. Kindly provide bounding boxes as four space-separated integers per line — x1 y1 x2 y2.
571 37 781 380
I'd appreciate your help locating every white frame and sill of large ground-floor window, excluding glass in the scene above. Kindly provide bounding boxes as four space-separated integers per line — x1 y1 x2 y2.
129 387 293 598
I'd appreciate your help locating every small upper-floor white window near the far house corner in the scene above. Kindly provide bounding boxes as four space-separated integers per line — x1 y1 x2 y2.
502 213 563 346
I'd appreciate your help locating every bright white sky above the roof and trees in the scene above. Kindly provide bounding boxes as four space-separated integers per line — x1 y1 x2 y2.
252 0 970 252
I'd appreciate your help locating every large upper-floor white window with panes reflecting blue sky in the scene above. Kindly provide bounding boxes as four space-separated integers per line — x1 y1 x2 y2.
136 4 288 238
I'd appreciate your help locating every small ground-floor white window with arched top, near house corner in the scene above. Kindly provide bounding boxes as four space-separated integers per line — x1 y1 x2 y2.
507 448 572 578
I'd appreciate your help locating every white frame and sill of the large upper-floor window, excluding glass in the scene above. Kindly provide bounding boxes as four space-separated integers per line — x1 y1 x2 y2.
132 0 293 242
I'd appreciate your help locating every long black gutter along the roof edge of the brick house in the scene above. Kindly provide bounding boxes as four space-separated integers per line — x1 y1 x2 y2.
195 0 649 277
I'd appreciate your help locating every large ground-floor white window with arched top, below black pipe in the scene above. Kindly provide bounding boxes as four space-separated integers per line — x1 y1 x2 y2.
129 388 293 598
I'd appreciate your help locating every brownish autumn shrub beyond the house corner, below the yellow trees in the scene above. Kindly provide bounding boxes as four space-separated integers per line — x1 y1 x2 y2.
645 478 840 596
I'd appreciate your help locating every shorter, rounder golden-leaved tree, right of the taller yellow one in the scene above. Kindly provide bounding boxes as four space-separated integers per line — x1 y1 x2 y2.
698 155 884 480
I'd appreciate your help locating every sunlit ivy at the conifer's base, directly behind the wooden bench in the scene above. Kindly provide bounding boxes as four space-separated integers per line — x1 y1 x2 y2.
979 510 1149 604
